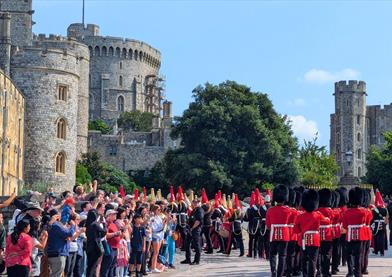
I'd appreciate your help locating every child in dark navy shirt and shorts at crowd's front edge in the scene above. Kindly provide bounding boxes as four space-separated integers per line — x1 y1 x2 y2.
129 214 146 277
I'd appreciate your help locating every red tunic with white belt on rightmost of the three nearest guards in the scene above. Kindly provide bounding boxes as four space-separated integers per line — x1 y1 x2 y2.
342 208 369 241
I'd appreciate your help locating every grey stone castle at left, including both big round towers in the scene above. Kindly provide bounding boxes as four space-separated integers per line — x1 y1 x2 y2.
0 0 172 190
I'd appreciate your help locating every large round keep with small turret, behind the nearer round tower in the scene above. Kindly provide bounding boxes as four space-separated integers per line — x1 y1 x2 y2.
68 23 163 124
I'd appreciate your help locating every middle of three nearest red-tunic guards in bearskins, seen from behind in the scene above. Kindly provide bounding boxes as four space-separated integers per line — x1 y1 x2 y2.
294 189 324 277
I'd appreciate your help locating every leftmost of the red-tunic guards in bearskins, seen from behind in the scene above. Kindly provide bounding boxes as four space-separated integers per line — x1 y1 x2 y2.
266 185 292 277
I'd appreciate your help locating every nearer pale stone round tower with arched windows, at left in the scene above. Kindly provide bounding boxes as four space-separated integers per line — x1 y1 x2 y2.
11 35 89 191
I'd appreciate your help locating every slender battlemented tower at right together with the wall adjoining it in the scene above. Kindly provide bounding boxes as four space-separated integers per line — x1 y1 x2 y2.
330 81 392 183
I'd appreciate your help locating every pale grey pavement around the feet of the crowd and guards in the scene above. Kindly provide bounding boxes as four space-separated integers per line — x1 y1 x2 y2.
161 232 392 277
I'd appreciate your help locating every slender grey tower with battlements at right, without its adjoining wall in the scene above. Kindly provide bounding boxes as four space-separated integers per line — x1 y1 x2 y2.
330 81 368 177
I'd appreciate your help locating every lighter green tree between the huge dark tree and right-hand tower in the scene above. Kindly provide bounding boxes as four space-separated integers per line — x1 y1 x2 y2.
296 138 338 188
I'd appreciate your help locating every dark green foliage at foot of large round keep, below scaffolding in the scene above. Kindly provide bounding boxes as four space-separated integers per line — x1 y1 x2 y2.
117 111 154 132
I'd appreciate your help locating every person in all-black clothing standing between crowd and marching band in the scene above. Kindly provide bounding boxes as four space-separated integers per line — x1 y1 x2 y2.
181 198 204 265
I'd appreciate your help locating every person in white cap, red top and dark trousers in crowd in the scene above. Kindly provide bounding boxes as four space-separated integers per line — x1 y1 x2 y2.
100 209 122 277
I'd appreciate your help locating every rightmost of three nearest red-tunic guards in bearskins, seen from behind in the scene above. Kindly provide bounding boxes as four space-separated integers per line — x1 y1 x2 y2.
342 187 368 277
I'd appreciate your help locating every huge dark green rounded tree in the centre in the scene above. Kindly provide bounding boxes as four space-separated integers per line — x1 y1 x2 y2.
155 81 297 196
